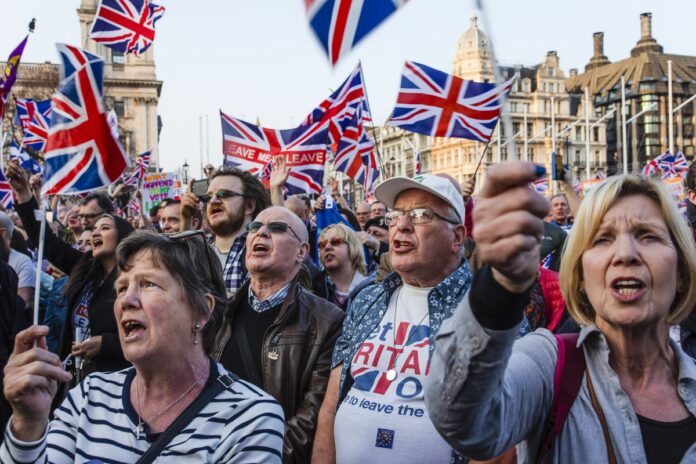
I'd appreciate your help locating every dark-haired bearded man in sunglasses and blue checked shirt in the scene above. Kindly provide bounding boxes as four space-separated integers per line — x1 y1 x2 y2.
181 167 270 297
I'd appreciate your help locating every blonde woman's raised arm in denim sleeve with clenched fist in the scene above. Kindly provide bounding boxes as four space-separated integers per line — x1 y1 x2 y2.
426 163 555 459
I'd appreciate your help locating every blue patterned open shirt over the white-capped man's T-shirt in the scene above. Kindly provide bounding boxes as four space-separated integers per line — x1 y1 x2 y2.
331 261 471 405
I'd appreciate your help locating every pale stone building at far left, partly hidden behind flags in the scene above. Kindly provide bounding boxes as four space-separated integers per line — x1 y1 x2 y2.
2 0 162 169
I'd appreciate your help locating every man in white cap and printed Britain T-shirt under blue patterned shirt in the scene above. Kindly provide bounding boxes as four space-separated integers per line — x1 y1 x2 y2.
312 174 471 463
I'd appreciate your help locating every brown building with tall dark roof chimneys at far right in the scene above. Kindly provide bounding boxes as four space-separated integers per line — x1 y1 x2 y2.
566 13 696 174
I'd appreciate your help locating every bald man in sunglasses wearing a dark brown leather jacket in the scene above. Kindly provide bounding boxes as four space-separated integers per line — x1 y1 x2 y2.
213 206 344 463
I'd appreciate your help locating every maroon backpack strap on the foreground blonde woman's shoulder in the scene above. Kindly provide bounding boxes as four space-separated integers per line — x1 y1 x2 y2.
539 333 585 460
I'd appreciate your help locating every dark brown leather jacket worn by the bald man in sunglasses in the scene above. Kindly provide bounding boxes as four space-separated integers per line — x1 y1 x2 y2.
213 281 345 463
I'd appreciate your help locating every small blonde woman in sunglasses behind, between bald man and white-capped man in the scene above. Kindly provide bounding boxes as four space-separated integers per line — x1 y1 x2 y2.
312 224 374 310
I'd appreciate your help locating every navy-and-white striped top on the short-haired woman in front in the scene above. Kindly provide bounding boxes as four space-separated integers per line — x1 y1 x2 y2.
0 363 285 464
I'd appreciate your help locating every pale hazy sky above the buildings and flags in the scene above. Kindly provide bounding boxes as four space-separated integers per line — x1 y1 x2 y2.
0 0 696 174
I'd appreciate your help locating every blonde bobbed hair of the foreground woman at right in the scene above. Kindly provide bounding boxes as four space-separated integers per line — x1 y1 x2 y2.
560 174 696 325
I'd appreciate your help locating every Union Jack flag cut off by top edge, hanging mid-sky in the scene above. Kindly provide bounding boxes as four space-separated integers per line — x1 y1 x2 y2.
304 0 407 65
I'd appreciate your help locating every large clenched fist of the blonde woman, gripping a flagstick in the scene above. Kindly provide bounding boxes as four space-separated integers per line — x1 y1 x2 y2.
474 161 549 293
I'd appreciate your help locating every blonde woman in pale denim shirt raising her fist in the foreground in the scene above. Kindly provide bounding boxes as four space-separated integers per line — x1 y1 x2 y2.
426 163 696 463
